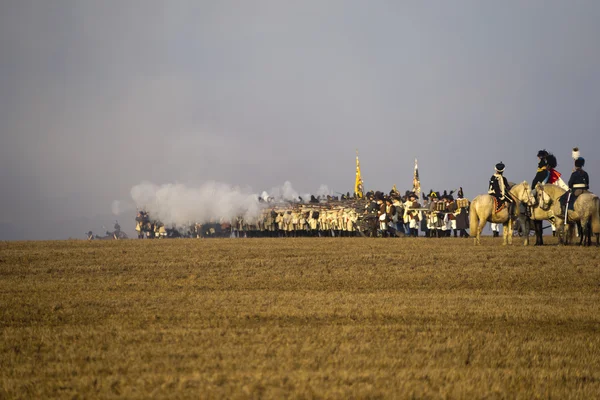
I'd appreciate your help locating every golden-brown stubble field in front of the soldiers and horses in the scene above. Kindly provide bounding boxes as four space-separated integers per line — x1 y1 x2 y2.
0 238 600 399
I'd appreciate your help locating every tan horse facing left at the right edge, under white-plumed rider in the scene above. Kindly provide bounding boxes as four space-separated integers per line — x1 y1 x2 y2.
534 184 600 246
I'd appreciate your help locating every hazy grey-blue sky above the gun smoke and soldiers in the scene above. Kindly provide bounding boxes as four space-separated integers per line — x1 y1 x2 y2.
0 0 600 240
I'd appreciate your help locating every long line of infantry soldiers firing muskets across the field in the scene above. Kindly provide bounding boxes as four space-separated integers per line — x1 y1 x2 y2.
136 189 469 238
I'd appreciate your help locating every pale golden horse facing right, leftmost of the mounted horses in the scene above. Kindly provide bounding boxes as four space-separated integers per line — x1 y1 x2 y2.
469 181 535 245
